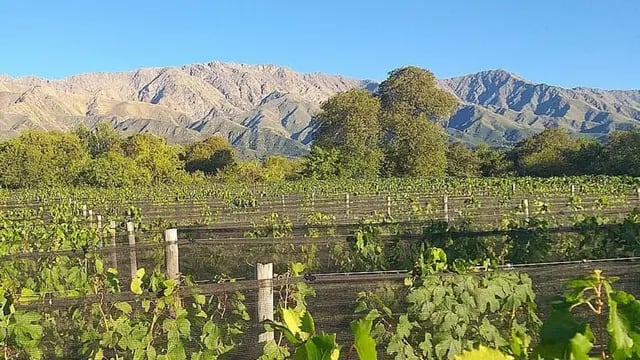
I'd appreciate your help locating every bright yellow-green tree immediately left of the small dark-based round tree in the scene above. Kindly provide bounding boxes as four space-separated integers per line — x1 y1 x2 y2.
123 133 185 183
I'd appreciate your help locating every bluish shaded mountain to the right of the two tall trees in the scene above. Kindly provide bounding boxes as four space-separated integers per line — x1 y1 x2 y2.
439 70 640 146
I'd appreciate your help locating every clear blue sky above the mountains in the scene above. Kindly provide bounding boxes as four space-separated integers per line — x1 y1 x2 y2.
0 0 640 89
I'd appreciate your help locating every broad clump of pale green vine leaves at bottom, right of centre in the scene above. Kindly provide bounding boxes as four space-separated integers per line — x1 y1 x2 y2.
356 249 539 359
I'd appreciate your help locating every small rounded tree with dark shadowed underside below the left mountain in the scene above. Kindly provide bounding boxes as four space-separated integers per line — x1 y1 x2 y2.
184 135 235 174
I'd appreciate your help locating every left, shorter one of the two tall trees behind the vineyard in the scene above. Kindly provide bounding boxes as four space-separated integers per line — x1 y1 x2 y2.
314 89 382 178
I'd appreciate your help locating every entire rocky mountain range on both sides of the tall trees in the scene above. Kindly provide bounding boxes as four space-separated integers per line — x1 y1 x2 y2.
0 62 640 157
